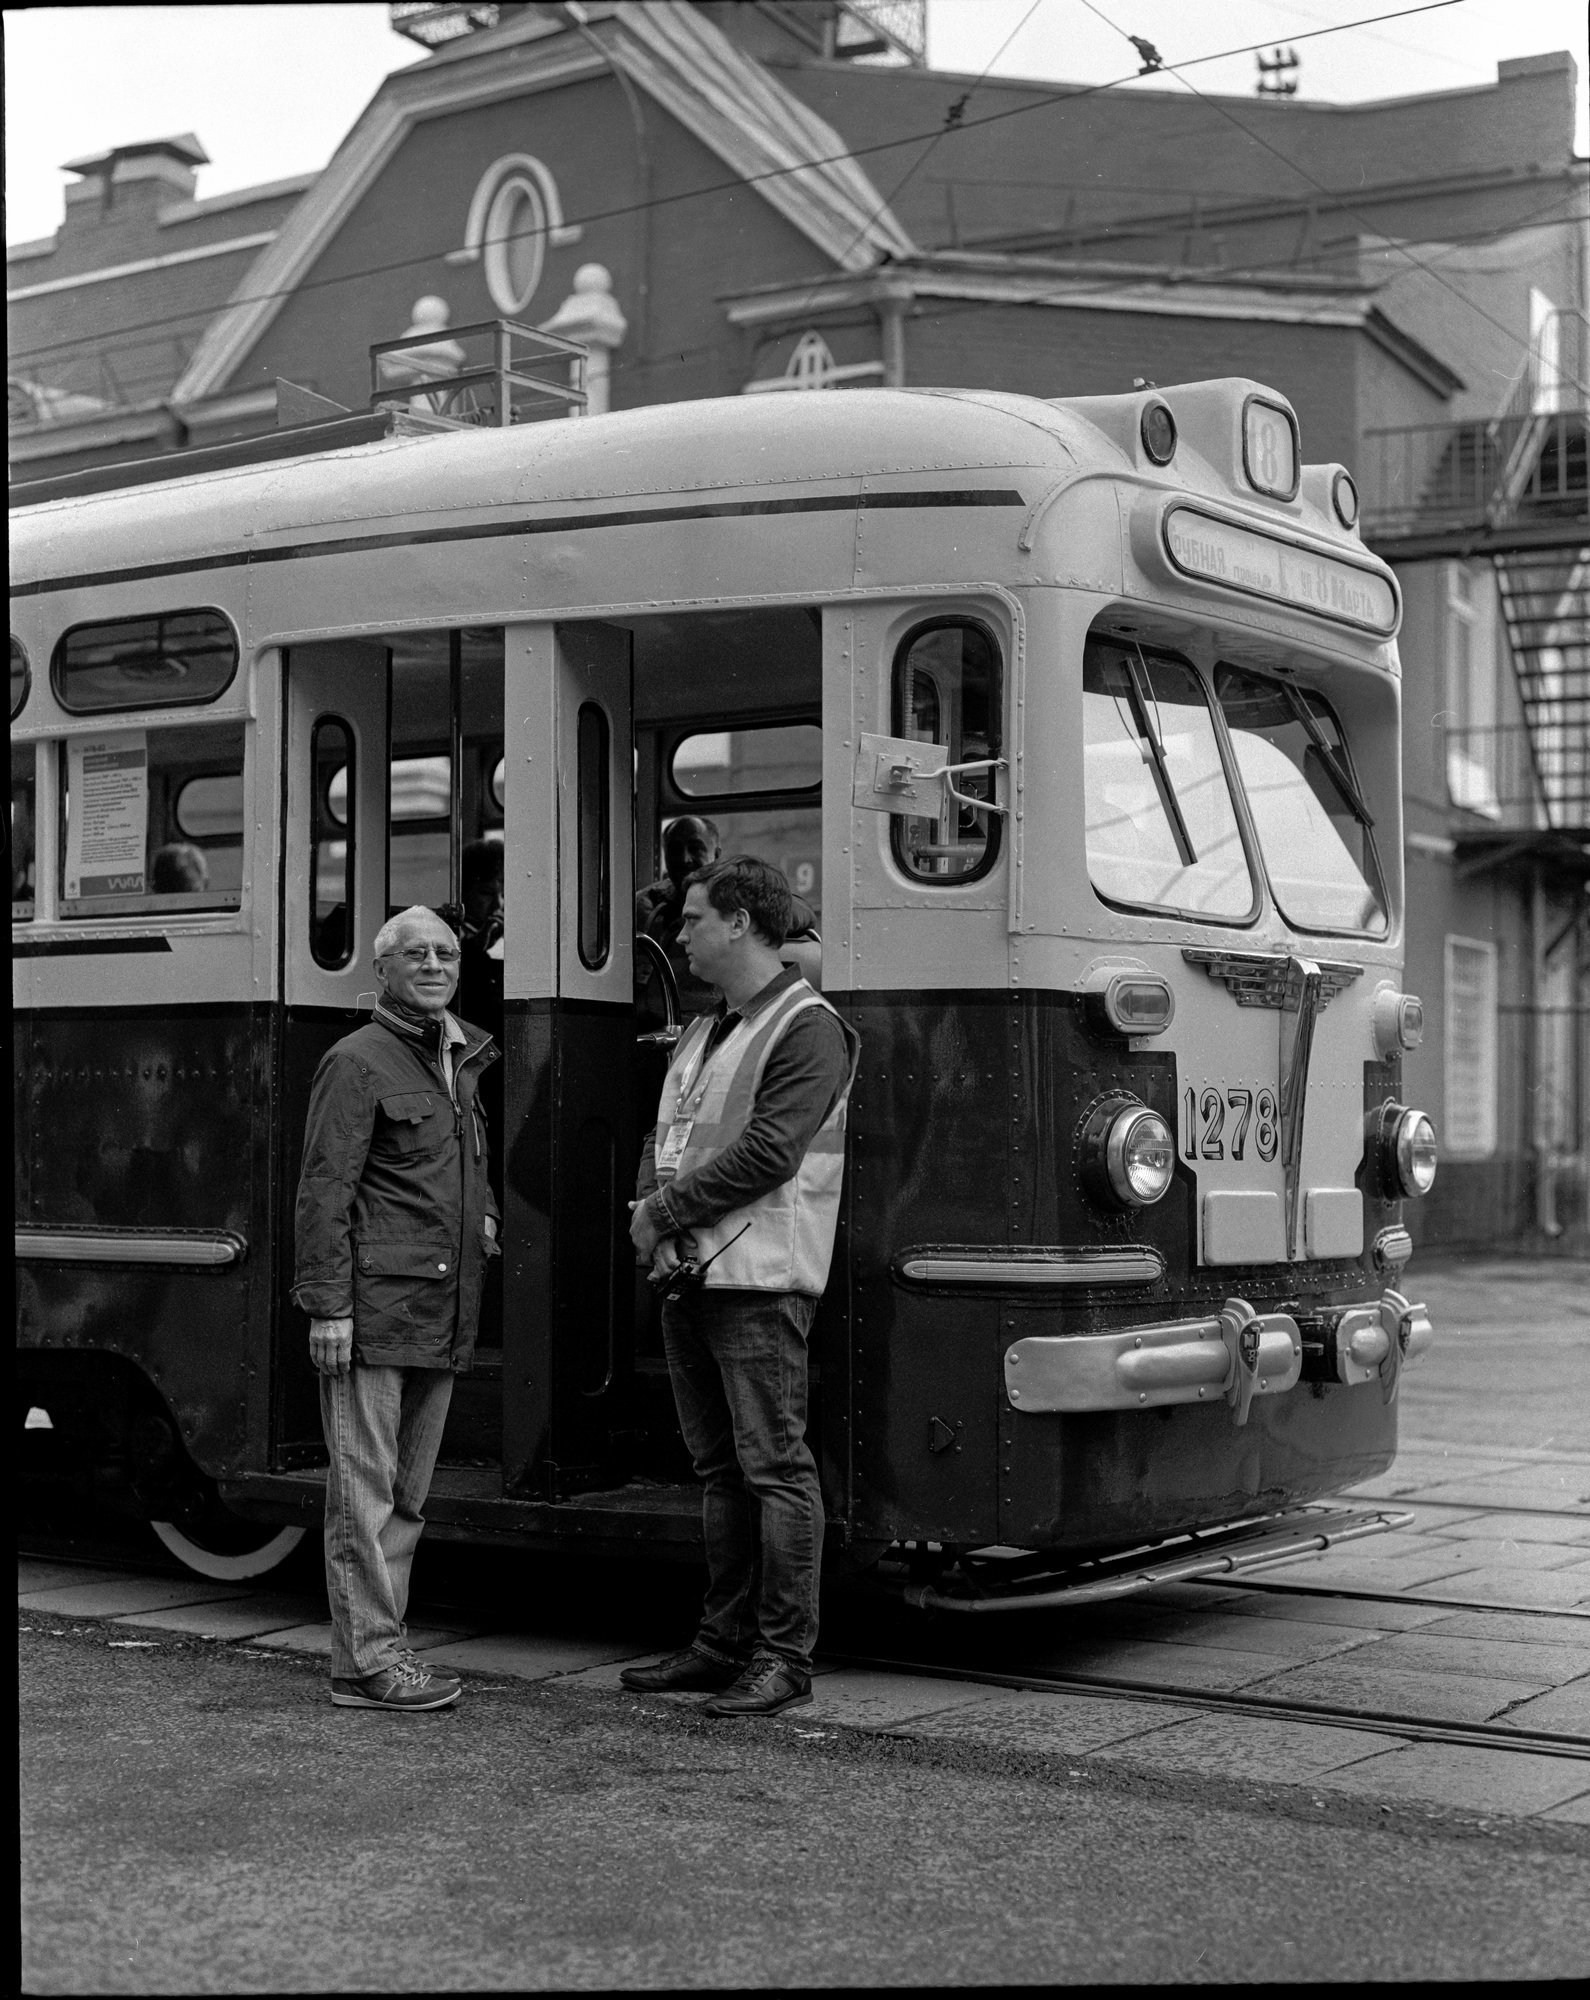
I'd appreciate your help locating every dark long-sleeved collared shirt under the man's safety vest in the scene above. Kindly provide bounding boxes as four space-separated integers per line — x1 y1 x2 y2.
636 966 850 1236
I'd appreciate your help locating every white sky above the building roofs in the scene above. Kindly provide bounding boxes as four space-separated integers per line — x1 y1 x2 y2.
4 0 1590 242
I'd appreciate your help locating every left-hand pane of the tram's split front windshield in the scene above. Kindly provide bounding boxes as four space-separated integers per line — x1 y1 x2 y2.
1082 638 1258 924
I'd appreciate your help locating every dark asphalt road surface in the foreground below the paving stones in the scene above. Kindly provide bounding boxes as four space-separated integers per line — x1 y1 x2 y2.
20 1614 1590 1994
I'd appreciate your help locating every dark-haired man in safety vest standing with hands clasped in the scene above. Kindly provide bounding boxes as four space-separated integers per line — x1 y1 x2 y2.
620 854 858 1716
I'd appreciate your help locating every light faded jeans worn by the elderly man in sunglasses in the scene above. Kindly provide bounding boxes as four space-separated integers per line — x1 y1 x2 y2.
320 1362 452 1680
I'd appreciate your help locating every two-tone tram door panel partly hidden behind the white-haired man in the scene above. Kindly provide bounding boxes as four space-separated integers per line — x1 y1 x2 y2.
276 640 388 1470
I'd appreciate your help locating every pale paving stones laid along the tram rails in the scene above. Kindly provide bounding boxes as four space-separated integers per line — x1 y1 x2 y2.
18 1538 1590 1826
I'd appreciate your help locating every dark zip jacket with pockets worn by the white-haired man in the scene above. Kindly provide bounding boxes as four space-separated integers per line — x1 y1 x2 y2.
292 1008 500 1370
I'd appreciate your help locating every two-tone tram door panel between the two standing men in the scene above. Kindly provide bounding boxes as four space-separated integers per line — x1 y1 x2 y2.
504 624 634 1498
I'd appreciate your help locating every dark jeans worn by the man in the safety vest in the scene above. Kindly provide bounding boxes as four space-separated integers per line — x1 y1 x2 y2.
662 1288 822 1674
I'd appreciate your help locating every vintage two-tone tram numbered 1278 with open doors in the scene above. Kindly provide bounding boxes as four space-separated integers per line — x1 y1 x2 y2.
12 380 1434 1604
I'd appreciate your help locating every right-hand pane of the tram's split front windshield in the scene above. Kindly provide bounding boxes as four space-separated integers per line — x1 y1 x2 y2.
1214 666 1386 936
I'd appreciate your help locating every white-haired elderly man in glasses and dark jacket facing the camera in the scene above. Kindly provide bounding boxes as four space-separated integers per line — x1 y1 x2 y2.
292 906 498 1714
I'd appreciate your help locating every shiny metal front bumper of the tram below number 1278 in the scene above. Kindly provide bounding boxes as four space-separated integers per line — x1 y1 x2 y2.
1004 1292 1434 1424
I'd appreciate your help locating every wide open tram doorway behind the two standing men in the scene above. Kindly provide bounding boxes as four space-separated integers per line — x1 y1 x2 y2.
276 606 822 1502
